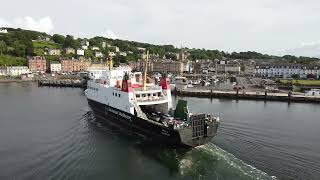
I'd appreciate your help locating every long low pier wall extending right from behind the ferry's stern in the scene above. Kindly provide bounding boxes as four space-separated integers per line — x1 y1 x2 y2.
172 90 320 103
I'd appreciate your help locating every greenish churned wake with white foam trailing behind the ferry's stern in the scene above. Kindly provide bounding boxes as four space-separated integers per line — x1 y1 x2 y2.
179 143 276 180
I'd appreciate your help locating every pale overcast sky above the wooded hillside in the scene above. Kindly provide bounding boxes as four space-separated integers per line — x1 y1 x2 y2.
0 0 320 56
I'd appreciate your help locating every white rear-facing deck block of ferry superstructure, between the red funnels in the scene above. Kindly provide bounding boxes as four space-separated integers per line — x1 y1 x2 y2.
133 86 168 105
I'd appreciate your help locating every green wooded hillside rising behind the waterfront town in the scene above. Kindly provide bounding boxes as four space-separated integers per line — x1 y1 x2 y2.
0 28 319 65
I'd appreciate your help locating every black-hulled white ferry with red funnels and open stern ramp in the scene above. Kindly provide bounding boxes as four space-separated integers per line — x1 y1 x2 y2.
85 56 220 147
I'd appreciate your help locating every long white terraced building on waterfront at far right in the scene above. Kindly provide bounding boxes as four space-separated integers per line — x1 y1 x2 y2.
255 65 320 78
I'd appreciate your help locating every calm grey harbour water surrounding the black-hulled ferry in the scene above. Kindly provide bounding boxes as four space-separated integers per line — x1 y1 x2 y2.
0 83 320 180
